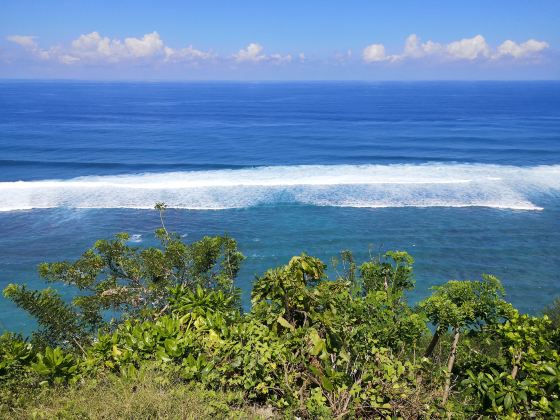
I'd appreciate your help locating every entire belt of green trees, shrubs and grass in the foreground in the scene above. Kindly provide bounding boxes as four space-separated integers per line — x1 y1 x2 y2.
0 203 560 419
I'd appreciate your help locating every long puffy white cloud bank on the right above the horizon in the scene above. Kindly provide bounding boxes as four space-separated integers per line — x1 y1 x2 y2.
362 34 549 63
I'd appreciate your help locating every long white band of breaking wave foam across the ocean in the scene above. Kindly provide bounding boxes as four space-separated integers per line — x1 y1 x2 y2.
0 163 560 211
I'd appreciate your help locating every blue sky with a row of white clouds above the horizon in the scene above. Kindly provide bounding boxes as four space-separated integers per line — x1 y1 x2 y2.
0 0 560 80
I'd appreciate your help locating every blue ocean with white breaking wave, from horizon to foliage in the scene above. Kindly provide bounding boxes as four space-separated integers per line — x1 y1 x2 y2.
0 81 560 331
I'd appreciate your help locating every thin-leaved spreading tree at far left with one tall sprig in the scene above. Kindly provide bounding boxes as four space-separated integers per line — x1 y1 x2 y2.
4 203 244 346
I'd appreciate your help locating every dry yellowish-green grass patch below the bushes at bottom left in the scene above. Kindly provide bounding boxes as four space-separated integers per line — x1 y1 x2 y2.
0 371 275 419
